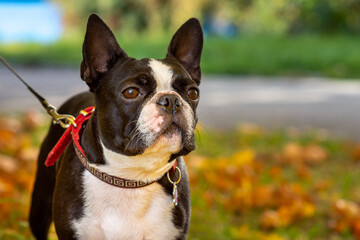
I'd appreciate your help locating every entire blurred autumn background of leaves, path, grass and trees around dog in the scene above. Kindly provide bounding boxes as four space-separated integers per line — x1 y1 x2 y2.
0 0 360 240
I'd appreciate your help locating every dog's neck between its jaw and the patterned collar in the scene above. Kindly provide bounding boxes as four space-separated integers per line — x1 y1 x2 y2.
81 113 174 182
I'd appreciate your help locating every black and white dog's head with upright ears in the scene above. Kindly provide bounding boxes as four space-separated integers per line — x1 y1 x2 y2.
81 15 203 163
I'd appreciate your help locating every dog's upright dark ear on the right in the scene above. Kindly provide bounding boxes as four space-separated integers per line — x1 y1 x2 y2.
167 18 203 84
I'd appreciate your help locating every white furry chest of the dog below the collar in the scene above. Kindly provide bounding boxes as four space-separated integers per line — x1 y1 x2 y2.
72 171 179 240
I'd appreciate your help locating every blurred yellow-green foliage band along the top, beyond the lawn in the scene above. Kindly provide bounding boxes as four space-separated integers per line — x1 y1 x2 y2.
53 0 360 35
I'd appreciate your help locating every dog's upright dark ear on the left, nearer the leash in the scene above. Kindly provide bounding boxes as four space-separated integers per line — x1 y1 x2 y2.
81 14 127 92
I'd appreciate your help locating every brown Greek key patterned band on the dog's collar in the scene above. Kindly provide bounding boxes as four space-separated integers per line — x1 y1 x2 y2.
73 144 152 188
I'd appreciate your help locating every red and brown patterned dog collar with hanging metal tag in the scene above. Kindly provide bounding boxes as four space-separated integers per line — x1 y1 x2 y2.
45 107 181 189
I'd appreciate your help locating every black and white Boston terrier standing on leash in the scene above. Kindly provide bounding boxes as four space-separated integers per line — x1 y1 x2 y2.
29 14 203 240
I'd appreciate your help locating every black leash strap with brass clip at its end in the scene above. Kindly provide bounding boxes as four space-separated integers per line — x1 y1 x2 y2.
0 56 76 128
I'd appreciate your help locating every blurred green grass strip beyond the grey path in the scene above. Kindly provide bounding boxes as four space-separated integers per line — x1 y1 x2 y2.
0 34 360 78
